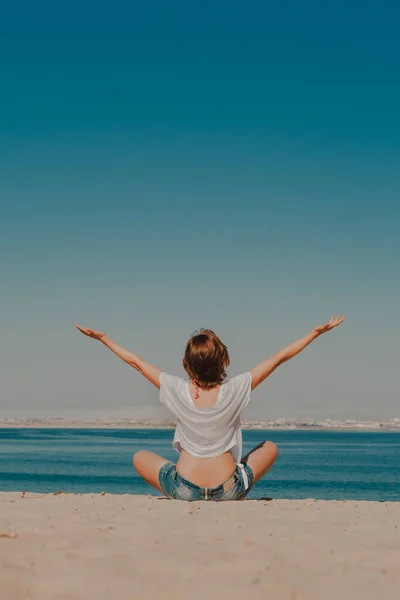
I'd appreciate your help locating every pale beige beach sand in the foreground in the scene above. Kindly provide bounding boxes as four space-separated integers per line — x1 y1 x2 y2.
0 493 400 600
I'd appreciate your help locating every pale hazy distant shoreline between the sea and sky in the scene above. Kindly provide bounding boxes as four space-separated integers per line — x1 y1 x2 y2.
0 418 400 432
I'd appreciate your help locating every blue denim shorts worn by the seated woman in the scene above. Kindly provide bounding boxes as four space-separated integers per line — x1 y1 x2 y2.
158 462 253 502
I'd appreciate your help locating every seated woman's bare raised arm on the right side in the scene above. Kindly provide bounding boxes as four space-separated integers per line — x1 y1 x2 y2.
250 315 346 390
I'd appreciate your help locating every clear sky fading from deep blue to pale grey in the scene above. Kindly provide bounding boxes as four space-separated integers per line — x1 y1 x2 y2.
0 0 400 418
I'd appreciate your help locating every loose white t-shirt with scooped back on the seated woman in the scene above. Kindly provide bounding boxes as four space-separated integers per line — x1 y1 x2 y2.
160 372 252 463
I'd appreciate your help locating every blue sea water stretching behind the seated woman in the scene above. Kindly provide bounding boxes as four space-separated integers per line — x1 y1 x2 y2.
0 428 400 501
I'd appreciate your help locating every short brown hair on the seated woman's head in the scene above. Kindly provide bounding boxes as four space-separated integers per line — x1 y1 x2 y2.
183 329 230 390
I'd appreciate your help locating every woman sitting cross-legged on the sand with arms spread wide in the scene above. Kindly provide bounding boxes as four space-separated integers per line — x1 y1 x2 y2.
77 315 345 501
